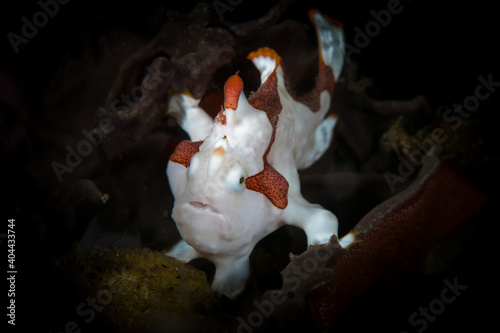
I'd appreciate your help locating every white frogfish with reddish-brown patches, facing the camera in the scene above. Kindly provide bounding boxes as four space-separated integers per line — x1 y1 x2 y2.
166 10 345 297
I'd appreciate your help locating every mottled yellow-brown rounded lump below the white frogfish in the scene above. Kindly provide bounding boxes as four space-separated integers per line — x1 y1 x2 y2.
68 248 214 332
